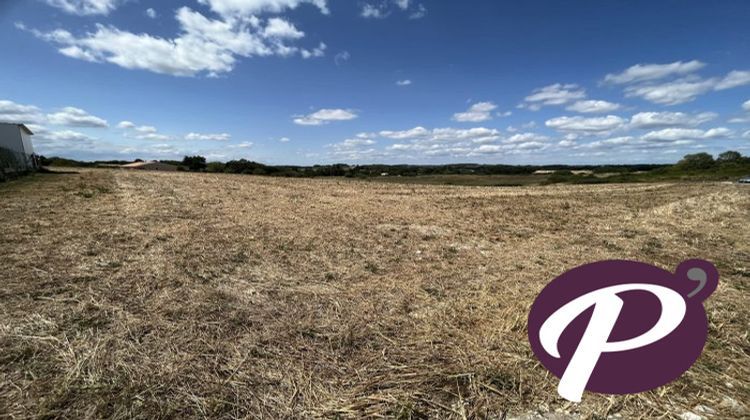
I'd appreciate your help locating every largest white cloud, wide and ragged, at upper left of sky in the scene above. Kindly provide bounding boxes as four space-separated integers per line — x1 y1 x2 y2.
19 5 326 76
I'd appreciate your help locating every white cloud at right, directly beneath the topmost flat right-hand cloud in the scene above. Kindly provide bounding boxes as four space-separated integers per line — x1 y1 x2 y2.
625 78 716 105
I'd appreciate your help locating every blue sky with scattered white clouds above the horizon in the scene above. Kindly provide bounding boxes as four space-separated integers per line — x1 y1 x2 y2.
0 0 750 165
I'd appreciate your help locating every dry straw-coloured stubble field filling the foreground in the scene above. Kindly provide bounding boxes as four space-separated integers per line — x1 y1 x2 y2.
0 170 750 418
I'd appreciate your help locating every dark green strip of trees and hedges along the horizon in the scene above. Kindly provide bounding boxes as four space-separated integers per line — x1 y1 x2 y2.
36 151 750 186
